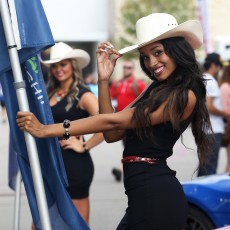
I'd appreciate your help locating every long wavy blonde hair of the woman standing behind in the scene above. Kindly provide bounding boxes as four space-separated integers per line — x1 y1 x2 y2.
47 59 84 111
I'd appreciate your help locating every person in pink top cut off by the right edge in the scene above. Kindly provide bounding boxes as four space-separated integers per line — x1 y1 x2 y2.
220 60 230 172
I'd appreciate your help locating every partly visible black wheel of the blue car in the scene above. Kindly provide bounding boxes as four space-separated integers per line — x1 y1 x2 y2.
184 205 216 230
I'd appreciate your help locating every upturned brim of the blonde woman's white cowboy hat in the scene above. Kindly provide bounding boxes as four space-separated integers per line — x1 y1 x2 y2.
41 49 90 69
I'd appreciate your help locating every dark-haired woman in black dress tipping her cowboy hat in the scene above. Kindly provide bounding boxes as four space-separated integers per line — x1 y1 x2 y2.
17 13 211 230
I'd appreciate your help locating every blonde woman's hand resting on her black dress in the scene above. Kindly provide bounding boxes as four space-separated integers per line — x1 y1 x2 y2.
59 136 85 153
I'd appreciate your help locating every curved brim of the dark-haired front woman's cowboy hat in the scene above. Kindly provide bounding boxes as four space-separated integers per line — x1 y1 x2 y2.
118 20 203 54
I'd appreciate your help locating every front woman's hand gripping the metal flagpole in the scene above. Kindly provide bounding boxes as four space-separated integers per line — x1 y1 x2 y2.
16 112 45 137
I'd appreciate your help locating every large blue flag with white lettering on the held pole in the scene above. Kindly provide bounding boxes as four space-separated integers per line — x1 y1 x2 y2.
0 0 89 230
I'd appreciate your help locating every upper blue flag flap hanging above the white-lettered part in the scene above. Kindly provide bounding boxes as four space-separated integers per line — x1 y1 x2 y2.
0 0 54 75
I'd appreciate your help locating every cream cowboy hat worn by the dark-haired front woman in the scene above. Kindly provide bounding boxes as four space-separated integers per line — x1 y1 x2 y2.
118 13 203 54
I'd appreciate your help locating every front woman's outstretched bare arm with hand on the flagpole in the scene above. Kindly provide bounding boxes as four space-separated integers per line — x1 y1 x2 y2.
17 109 133 138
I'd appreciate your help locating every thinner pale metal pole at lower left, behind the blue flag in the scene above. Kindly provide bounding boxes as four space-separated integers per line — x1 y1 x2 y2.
14 172 21 230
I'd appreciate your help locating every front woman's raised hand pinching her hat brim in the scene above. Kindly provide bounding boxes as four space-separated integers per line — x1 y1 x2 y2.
97 42 122 81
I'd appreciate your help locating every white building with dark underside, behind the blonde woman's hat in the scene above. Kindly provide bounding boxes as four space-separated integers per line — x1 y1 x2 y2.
41 0 115 74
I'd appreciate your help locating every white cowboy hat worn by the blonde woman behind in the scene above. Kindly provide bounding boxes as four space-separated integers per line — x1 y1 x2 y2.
41 42 90 69
